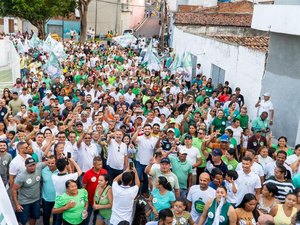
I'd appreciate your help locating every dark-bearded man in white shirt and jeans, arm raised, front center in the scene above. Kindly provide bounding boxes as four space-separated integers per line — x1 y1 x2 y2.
132 124 158 194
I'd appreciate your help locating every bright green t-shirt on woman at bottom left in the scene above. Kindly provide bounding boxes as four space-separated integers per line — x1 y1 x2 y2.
54 189 88 224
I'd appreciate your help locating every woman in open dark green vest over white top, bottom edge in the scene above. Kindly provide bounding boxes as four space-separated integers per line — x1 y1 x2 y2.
198 186 237 225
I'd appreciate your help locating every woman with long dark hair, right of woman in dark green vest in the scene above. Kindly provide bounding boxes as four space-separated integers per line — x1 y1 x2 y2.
235 193 260 225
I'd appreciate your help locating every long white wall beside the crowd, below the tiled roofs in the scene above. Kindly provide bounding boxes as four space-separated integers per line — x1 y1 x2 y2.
173 26 265 119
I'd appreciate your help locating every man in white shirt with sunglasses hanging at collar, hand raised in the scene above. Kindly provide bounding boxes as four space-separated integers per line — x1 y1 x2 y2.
106 130 128 183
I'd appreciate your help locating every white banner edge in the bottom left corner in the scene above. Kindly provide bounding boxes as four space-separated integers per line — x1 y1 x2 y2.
0 177 18 225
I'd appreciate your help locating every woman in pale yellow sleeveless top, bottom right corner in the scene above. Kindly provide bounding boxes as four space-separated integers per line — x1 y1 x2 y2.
274 192 298 225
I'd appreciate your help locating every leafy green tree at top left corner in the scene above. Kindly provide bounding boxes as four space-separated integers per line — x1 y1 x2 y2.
0 0 76 39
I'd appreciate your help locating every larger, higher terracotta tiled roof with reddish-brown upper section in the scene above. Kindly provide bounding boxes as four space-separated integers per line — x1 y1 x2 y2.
174 1 253 27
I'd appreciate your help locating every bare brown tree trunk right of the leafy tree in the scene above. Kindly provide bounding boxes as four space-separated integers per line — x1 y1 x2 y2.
78 0 91 43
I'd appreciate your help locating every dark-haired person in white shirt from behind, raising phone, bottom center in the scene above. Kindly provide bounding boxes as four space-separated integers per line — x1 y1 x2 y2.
110 167 140 225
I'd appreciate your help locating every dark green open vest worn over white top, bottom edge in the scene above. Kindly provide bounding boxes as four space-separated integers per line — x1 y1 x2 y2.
206 199 231 225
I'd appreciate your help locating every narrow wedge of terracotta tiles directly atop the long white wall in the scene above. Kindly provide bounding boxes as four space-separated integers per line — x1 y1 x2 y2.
210 36 269 52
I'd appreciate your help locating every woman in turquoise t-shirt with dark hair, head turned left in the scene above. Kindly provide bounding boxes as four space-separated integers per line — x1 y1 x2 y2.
149 176 176 218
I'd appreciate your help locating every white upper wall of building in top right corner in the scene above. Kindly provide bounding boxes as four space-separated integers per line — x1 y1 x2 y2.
251 5 300 35
